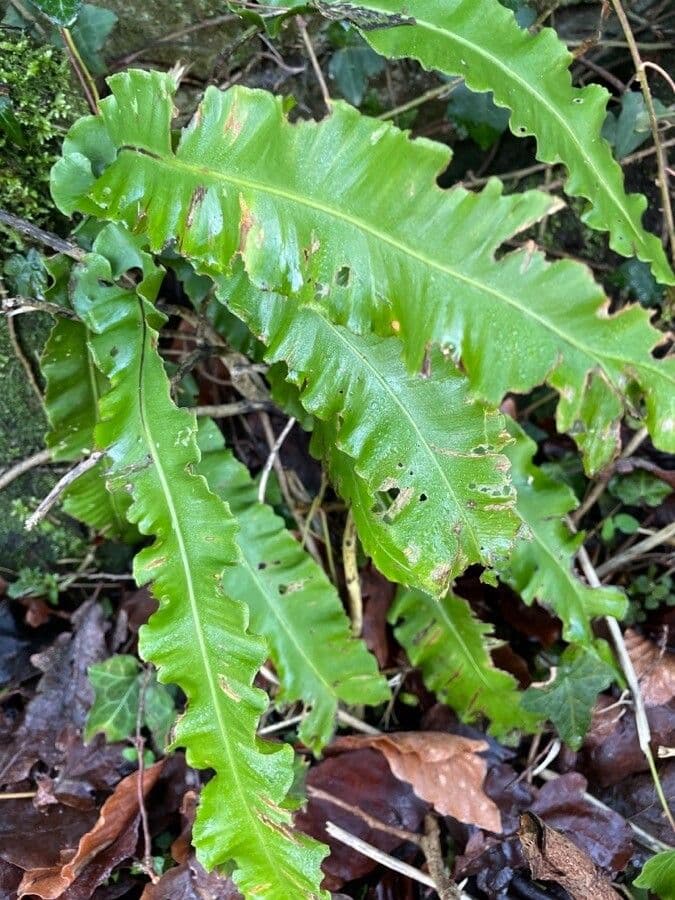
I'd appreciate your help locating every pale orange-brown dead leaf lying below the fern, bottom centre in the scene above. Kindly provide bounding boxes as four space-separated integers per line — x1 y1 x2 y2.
333 731 502 834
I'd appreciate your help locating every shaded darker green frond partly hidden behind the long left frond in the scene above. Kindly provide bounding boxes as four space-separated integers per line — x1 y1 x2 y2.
40 257 137 541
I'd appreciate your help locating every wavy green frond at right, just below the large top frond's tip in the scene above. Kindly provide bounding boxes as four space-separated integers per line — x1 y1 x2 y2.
499 420 627 646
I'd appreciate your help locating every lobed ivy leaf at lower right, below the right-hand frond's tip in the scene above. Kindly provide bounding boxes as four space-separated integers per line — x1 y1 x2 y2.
522 645 615 750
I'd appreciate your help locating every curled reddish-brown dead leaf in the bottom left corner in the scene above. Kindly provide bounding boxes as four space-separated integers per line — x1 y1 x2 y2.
18 760 165 900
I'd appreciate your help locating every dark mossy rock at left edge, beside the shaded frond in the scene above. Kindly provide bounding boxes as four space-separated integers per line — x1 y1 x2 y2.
0 313 86 578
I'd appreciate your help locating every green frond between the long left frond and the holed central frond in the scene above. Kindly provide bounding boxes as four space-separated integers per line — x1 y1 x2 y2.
198 422 390 751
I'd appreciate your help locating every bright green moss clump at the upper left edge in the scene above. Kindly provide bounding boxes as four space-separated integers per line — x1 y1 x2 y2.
0 29 87 253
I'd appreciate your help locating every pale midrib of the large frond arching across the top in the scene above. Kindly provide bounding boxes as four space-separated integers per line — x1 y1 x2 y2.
120 144 675 386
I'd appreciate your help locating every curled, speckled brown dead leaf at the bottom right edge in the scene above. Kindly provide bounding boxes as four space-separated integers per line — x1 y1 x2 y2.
518 812 618 900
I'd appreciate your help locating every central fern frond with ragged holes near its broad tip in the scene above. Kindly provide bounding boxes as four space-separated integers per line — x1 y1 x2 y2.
220 277 518 594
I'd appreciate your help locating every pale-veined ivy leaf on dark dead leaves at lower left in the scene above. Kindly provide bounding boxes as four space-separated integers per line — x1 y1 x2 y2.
84 654 141 743
